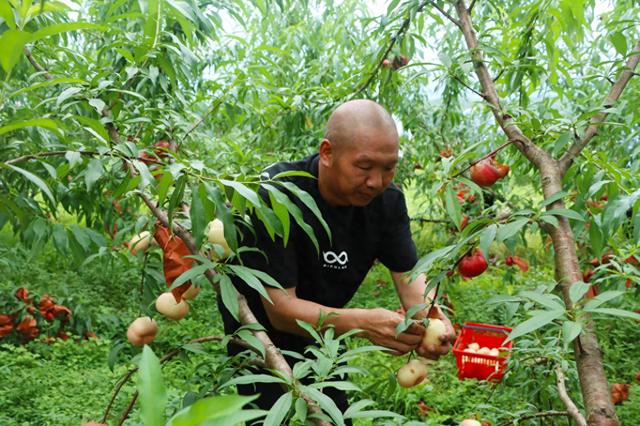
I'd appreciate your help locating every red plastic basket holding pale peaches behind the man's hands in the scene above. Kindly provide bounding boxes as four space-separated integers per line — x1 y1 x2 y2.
453 322 513 382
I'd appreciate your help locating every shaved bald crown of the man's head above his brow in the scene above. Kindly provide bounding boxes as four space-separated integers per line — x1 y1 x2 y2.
324 99 398 151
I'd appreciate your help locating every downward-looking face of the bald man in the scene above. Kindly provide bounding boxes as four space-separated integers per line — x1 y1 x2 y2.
326 134 398 206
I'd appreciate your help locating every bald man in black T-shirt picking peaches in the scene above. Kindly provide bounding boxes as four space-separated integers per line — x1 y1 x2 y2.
222 100 455 411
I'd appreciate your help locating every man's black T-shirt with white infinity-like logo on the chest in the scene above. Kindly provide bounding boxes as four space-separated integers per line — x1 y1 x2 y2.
221 154 417 351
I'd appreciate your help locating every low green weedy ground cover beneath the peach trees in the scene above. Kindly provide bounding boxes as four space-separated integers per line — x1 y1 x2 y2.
0 188 640 425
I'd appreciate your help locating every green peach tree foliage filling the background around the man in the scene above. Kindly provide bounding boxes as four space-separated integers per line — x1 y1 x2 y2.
0 0 640 421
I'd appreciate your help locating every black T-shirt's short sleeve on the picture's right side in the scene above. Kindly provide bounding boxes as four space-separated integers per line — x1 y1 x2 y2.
378 189 418 272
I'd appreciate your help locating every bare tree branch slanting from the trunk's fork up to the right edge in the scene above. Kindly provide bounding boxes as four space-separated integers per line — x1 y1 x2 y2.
558 41 640 176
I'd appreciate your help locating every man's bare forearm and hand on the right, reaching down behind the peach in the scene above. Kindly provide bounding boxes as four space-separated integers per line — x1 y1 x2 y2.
391 272 456 359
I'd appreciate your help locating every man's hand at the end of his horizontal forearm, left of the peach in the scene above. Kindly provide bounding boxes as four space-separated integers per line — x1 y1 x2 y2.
360 308 424 355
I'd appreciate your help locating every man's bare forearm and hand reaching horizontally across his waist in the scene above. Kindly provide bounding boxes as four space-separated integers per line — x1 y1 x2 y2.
262 288 424 354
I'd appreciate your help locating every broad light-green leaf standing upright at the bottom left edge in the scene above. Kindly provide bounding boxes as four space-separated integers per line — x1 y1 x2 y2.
138 345 167 426
